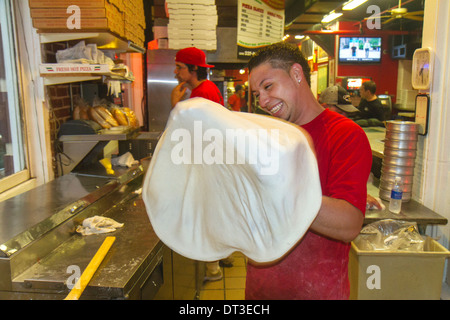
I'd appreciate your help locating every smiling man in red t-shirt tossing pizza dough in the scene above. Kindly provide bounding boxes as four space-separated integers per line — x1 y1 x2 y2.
245 42 372 300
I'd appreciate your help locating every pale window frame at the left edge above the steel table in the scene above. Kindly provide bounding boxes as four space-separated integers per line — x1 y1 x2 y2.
0 0 54 202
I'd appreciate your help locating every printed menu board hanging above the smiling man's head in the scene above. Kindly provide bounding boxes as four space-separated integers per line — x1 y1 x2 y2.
237 0 284 58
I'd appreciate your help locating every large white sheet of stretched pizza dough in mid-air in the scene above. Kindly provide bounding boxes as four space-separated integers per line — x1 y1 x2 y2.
142 98 322 262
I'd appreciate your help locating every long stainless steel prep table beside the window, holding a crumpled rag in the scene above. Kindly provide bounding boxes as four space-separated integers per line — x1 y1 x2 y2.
0 167 200 299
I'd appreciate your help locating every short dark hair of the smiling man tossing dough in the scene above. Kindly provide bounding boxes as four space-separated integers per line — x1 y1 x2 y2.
248 42 311 86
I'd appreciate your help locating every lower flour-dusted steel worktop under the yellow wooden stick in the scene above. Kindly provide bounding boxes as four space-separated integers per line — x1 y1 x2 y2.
12 199 165 299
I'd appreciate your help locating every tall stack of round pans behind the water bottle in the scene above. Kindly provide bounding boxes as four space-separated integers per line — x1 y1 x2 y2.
380 121 419 202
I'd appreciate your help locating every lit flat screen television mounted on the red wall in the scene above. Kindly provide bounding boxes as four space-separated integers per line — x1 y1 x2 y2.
339 37 381 64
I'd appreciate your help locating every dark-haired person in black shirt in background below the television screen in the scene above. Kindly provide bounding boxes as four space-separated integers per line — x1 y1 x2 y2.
358 81 386 122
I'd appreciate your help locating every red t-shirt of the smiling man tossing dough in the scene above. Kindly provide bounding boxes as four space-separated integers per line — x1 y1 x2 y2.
245 109 372 300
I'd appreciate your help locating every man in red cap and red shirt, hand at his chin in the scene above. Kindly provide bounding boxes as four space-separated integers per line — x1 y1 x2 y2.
171 47 224 107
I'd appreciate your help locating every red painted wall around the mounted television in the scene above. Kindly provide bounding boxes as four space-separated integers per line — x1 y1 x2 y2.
337 22 398 103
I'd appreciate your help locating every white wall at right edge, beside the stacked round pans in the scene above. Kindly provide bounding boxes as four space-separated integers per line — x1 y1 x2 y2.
416 0 450 290
